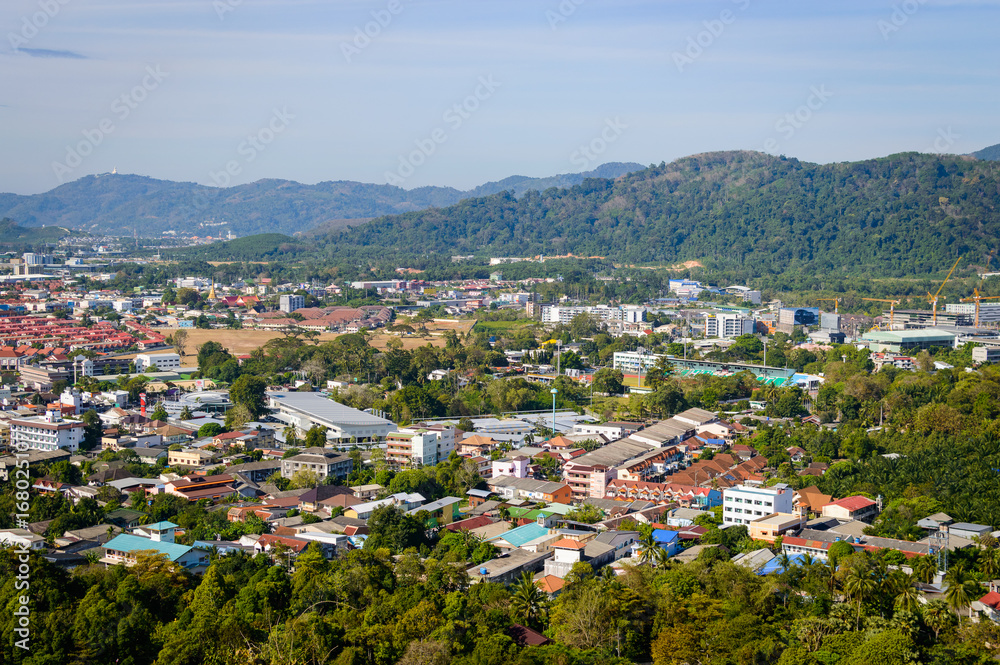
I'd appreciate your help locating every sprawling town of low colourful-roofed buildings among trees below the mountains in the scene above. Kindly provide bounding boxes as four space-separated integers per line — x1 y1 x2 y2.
0 243 1000 660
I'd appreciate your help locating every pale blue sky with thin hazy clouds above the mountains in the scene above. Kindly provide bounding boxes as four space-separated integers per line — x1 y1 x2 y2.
0 0 1000 194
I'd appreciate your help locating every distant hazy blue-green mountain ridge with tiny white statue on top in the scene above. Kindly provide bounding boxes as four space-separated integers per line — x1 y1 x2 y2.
0 163 643 236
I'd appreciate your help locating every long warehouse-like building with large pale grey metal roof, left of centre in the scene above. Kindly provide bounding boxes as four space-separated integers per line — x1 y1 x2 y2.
268 392 396 442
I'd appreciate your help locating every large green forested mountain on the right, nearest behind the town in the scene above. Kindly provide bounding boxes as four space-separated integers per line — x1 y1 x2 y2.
320 151 1000 277
